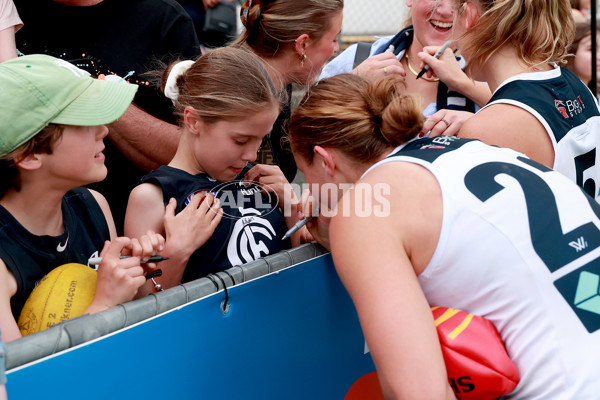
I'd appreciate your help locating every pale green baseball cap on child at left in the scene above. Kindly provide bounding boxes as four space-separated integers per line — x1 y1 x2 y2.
0 54 138 155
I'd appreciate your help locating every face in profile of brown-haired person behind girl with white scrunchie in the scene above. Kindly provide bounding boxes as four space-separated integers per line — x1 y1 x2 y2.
299 10 342 84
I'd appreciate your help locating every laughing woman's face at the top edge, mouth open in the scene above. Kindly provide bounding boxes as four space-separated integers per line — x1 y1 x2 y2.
406 0 455 47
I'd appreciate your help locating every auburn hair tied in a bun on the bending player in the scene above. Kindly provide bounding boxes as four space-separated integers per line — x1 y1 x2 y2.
290 74 424 164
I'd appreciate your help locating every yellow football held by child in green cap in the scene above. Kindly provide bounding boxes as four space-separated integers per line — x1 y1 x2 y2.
18 263 97 336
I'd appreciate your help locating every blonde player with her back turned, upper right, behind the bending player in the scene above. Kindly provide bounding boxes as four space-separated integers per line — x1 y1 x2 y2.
442 0 600 197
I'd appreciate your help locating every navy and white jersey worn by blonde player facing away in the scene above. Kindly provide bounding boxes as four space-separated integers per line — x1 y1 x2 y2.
484 67 600 198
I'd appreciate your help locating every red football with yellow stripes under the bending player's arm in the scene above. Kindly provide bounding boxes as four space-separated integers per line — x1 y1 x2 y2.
431 307 519 400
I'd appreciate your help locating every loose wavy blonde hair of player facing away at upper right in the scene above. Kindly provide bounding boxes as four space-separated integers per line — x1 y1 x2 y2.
455 0 575 76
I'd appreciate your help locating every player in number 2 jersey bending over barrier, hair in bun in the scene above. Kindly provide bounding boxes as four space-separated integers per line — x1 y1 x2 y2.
290 74 600 400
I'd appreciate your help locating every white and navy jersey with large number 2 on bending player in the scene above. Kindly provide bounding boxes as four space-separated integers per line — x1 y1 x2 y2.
374 136 600 400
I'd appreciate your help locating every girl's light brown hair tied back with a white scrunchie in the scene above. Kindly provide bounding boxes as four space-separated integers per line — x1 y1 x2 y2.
161 47 282 124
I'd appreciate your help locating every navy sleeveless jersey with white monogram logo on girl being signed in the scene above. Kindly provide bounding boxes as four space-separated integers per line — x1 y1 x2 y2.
141 166 290 282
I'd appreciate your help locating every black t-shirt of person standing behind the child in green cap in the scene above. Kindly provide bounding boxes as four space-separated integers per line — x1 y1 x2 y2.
15 0 200 232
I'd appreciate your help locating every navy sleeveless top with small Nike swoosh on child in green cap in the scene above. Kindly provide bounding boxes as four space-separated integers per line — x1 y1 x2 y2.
0 188 110 319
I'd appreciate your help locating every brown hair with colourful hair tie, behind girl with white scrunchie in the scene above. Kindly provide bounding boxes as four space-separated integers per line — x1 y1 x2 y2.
233 0 344 57
